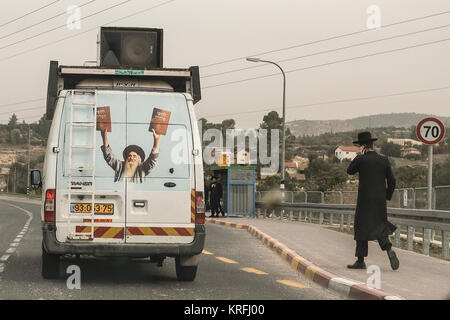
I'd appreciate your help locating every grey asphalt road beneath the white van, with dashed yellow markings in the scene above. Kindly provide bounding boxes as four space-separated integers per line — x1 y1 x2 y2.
0 199 342 300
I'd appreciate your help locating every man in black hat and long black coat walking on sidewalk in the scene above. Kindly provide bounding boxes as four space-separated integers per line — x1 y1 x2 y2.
347 132 400 270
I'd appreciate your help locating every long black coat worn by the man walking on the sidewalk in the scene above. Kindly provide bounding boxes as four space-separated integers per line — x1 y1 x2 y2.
347 151 397 241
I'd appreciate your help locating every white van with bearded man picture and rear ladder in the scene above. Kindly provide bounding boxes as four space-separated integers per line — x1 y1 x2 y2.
31 28 205 281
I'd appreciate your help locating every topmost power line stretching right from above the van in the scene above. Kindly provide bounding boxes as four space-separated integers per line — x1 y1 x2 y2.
201 10 450 68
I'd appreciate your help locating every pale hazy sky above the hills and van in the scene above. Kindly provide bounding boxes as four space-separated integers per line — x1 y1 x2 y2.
0 0 450 128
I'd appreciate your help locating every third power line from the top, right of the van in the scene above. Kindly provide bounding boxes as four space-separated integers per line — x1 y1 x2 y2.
202 38 450 90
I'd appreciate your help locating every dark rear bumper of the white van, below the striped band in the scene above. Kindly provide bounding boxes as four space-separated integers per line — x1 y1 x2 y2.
42 223 206 257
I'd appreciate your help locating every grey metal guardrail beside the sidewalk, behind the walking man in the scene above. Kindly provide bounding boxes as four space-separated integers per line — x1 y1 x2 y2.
256 201 450 259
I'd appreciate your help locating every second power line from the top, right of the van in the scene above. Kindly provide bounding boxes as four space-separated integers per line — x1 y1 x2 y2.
202 24 450 78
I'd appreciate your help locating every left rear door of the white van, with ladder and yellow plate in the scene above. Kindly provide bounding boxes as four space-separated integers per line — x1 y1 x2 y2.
54 90 127 243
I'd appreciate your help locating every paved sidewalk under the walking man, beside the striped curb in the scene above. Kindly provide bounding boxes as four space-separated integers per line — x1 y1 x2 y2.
208 217 450 300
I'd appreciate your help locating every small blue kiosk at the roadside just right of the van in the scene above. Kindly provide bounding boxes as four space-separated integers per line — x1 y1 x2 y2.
213 165 256 217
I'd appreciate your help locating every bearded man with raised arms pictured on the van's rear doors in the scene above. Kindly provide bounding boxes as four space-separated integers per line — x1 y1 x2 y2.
101 129 161 183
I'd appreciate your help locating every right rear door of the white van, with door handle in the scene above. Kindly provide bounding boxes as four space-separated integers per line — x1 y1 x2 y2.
125 91 195 243
